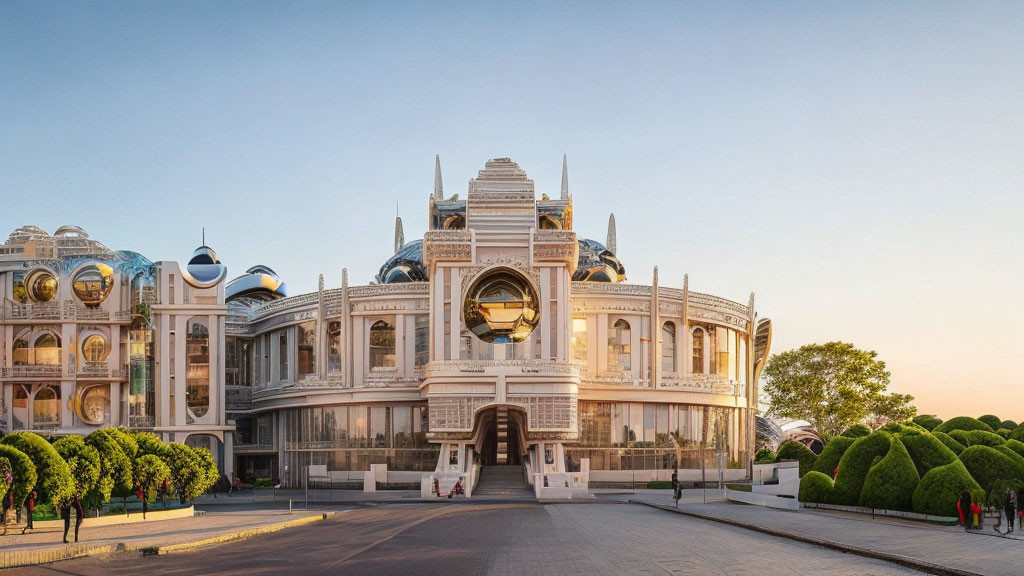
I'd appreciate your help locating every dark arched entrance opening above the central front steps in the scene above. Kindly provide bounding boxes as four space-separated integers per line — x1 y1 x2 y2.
473 404 529 466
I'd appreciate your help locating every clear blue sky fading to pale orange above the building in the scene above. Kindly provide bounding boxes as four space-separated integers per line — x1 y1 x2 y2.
0 0 1024 421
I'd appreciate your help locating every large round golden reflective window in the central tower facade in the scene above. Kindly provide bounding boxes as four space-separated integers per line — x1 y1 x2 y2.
463 270 541 343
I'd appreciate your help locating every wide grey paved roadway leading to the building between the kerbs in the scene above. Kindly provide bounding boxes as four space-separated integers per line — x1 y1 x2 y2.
11 503 937 576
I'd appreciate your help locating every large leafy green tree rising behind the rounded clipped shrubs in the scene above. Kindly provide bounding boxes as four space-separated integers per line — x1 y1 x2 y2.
764 342 909 440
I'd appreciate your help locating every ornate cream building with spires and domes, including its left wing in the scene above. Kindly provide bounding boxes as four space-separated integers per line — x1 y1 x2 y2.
0 158 771 497
